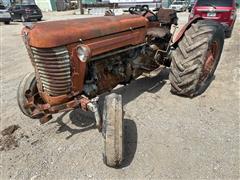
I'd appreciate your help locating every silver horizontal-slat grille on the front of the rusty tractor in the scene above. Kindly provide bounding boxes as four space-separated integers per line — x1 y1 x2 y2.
31 47 71 96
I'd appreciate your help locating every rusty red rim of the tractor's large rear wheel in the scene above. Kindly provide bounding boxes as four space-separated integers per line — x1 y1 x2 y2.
200 41 219 82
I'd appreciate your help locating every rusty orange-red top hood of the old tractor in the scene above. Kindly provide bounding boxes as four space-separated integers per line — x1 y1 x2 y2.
23 15 148 48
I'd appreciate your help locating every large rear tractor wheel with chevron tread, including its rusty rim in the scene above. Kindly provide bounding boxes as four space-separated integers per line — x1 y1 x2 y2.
169 20 224 97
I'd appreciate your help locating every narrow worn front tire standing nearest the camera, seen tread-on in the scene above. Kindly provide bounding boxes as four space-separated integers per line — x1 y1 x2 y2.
102 94 124 167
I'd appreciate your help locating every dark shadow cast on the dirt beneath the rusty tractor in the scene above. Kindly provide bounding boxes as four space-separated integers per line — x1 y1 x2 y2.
49 69 169 168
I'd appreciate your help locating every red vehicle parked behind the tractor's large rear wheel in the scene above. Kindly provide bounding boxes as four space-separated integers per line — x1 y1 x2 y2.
189 0 238 38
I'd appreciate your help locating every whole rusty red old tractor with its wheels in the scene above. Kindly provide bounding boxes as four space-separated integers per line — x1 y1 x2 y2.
17 6 224 167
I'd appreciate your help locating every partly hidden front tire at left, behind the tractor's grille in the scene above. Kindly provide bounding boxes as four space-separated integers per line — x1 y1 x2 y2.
17 73 37 118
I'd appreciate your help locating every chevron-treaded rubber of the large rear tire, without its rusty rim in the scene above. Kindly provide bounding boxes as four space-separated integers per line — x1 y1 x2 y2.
169 20 224 97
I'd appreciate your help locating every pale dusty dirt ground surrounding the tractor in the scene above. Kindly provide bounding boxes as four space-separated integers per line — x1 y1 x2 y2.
0 12 240 180
